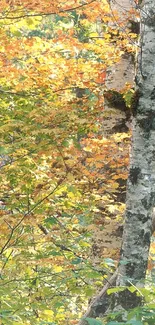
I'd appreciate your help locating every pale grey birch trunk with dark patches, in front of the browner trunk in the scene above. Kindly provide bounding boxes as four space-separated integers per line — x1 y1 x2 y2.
116 0 155 285
